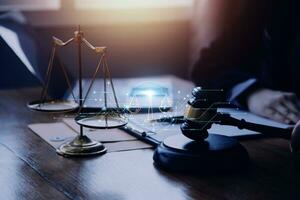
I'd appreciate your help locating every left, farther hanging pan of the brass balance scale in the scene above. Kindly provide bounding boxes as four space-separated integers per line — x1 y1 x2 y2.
27 100 79 113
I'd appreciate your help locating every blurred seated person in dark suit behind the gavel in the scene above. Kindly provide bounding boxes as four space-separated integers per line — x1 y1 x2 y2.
191 0 300 123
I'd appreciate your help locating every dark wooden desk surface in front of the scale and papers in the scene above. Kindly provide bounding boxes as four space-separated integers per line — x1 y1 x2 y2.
0 89 300 200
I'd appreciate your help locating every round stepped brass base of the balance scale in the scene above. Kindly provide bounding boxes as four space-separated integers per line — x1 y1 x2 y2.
56 136 107 156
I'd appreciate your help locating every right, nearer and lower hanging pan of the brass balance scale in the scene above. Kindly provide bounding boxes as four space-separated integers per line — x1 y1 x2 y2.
75 113 128 129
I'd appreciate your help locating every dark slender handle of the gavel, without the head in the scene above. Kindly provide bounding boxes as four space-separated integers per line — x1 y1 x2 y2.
216 113 293 139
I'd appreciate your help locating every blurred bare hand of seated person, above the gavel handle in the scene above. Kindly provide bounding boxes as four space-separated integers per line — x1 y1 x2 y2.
247 89 300 124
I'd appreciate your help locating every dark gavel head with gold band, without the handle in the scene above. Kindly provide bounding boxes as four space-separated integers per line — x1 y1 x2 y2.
180 87 224 142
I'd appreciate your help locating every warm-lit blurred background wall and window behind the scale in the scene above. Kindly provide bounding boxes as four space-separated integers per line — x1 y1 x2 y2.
0 0 194 82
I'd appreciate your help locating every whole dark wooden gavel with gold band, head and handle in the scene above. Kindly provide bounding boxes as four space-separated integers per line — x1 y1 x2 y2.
180 87 300 152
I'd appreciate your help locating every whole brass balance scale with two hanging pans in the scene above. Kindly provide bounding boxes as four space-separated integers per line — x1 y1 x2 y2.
28 26 128 156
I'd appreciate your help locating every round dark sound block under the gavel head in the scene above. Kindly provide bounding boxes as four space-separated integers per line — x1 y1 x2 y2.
153 134 249 174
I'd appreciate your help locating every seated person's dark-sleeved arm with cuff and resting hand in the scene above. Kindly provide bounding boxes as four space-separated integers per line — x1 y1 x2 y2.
191 0 300 123
